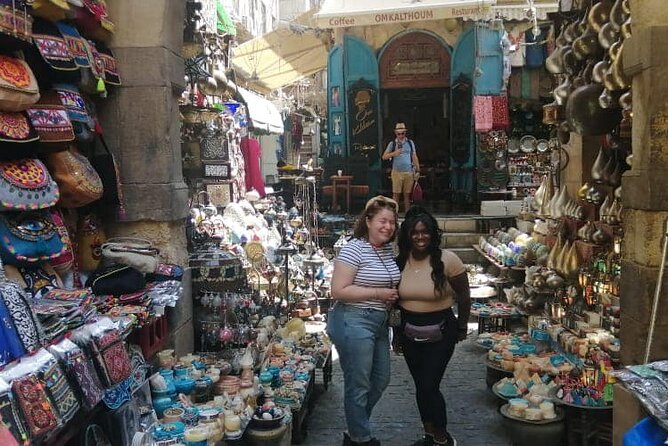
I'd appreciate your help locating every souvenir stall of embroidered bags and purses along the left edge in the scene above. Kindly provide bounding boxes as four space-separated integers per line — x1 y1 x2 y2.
0 0 194 445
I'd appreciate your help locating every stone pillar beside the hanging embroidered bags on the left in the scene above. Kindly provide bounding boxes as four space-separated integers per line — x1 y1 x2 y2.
99 0 193 353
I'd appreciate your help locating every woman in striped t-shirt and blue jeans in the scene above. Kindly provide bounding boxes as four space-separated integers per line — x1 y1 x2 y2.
327 195 400 446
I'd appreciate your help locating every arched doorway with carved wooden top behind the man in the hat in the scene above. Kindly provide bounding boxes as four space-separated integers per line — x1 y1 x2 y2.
379 30 451 213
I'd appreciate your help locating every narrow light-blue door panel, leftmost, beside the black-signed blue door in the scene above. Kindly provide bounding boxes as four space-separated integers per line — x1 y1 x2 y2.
327 45 347 156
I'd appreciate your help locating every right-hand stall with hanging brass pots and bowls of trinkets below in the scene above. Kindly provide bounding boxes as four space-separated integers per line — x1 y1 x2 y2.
474 1 632 445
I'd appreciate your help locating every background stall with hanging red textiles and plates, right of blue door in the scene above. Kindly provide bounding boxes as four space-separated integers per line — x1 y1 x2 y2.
473 16 561 215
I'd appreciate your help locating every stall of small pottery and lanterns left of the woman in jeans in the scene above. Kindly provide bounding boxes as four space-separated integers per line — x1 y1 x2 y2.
177 180 332 441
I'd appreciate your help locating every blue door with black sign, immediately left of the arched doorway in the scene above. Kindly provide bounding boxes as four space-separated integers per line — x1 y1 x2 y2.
343 35 382 195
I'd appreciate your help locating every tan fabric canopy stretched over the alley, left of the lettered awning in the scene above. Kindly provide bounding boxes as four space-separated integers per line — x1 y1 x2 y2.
231 11 329 92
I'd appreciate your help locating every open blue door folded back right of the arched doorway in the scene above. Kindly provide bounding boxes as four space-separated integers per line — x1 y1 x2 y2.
450 25 503 199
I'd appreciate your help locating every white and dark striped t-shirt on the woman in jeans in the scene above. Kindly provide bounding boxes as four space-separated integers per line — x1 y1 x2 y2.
336 238 401 310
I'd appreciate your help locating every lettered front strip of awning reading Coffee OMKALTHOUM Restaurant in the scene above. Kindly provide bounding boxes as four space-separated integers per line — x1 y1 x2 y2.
317 5 490 28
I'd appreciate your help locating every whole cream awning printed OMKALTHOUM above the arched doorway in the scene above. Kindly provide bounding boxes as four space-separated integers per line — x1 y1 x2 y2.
315 0 496 28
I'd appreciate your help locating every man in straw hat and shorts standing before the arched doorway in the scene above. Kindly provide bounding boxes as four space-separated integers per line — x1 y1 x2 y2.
382 122 420 211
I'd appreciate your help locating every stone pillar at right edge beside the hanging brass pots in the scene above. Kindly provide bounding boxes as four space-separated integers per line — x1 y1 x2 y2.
621 0 668 364
